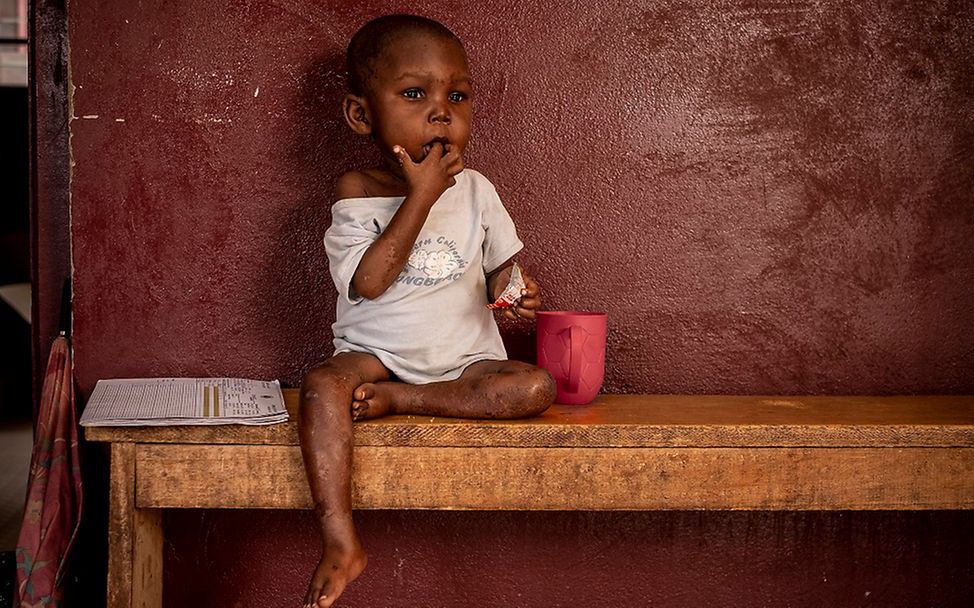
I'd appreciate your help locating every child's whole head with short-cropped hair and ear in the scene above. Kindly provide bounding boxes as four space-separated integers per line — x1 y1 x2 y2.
343 15 472 162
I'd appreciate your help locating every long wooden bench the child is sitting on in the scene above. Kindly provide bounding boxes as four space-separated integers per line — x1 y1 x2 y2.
86 390 974 608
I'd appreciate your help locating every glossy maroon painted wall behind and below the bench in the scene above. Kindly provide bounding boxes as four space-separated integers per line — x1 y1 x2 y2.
63 0 974 606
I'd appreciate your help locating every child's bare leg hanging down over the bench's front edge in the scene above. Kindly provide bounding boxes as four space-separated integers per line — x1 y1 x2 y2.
298 353 389 608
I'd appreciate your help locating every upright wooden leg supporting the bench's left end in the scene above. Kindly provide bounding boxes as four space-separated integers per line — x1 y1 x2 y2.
108 443 163 608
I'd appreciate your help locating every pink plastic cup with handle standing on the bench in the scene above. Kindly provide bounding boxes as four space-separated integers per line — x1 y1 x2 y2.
537 311 608 405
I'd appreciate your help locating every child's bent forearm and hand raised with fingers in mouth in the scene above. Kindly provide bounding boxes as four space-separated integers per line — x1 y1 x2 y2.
348 143 463 300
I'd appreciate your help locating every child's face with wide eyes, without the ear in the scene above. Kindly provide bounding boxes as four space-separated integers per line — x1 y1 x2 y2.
366 34 472 167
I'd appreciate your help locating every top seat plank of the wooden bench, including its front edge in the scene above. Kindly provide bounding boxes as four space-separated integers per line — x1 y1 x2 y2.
85 390 974 447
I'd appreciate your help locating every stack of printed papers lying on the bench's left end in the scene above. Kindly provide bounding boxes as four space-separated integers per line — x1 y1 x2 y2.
81 378 287 426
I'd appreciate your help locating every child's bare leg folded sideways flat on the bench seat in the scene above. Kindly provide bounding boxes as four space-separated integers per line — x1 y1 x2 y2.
352 361 555 420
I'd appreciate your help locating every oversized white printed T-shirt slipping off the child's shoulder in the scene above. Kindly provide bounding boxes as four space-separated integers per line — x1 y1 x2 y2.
325 169 523 384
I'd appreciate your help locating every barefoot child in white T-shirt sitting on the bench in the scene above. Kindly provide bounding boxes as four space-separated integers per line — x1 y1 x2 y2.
300 15 555 608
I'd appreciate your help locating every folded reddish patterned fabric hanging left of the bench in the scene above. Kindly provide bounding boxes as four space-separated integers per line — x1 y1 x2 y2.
16 335 81 608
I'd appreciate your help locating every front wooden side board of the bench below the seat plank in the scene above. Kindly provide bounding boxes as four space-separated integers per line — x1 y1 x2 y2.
136 445 974 511
